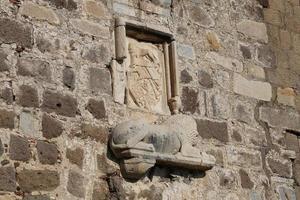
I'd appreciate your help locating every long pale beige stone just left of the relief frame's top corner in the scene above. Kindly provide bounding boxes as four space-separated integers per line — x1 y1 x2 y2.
70 19 109 38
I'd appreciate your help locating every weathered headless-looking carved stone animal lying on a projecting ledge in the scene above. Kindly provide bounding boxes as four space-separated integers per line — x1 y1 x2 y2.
110 115 215 179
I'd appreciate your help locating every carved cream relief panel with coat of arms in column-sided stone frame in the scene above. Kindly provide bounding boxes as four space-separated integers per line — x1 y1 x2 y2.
112 18 180 114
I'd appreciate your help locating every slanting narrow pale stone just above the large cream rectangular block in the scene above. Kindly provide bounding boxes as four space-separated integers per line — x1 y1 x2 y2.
206 52 243 72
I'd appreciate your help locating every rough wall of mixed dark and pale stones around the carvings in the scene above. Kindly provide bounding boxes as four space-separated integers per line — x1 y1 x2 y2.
0 0 300 200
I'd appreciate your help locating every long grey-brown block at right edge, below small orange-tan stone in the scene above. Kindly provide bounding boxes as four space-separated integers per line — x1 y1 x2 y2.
259 107 300 130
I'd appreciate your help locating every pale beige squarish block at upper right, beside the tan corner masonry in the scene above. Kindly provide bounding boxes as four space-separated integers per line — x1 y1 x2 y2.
237 20 268 43
